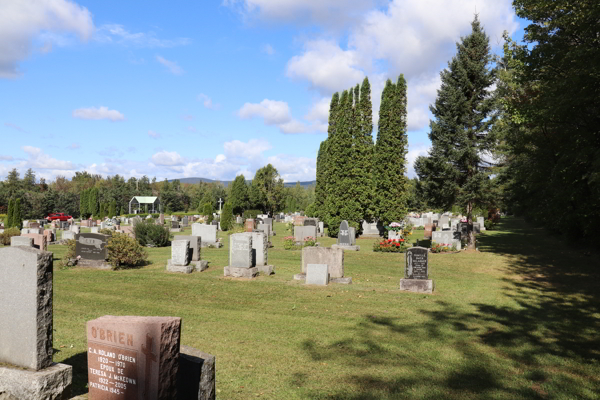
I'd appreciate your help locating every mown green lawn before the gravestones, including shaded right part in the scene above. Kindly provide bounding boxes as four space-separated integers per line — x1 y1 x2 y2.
49 218 600 400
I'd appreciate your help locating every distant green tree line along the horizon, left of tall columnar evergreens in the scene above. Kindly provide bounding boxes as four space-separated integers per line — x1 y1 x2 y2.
0 164 314 222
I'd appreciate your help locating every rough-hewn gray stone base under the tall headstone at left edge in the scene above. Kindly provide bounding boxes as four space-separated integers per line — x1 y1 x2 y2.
0 364 73 400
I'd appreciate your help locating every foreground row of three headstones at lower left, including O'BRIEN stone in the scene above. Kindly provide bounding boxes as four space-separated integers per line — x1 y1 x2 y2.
0 247 216 400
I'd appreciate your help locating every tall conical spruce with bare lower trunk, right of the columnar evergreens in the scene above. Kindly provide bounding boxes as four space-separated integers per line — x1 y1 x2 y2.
415 16 496 249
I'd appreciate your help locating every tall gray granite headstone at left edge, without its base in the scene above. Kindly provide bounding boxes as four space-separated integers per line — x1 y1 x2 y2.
0 246 53 371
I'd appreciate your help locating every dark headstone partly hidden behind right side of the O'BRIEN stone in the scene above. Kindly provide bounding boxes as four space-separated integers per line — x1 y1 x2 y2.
177 346 216 400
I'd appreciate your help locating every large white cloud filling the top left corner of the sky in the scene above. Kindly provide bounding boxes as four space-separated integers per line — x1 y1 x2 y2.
0 0 94 78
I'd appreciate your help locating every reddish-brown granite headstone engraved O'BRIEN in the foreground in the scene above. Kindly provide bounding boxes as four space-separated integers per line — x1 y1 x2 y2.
87 315 181 400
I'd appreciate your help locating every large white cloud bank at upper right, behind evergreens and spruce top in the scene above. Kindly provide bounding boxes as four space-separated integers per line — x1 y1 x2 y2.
278 0 518 130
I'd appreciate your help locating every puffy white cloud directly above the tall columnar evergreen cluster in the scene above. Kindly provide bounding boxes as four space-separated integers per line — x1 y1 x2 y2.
286 40 365 93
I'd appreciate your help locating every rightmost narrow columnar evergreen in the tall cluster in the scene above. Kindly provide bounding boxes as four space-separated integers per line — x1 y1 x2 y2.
373 75 408 225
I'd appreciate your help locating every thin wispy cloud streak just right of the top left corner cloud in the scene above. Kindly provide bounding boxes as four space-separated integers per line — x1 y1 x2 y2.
94 24 191 48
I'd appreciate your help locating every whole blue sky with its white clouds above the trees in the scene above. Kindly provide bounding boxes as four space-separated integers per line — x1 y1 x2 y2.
0 0 525 181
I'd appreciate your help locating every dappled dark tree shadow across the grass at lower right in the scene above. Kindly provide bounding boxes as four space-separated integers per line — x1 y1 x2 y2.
302 220 600 400
